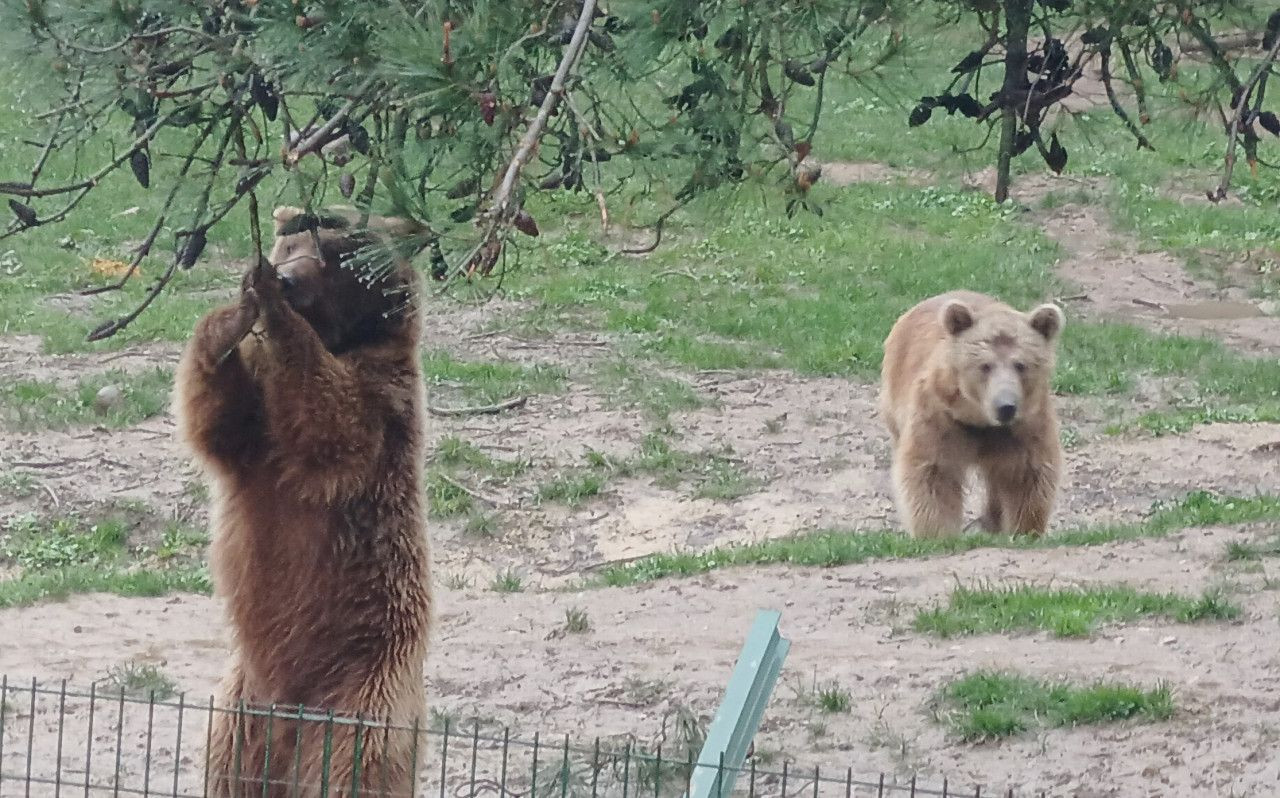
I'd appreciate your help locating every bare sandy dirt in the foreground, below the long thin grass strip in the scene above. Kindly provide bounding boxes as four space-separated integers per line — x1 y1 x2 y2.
0 530 1280 795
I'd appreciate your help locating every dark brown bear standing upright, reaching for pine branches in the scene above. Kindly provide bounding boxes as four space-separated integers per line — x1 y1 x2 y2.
175 208 431 798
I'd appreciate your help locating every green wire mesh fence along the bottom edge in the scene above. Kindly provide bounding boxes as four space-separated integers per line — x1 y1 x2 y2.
0 678 1039 798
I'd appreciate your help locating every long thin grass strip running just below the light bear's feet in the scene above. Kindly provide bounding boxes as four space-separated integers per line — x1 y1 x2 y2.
586 491 1280 587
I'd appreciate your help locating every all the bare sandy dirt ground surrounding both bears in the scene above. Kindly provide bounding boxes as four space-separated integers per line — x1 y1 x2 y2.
0 171 1280 795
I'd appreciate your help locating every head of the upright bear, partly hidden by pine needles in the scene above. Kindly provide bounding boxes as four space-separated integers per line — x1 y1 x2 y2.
269 206 420 352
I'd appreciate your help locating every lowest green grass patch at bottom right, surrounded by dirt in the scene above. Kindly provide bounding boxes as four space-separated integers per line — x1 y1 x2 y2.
937 670 1174 742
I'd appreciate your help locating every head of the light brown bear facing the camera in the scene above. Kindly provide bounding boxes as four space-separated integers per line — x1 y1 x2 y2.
941 300 1065 427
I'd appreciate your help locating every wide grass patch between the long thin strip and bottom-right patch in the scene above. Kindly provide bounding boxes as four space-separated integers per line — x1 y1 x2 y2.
913 584 1240 638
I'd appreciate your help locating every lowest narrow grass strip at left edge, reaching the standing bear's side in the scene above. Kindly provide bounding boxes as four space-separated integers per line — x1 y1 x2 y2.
0 565 212 608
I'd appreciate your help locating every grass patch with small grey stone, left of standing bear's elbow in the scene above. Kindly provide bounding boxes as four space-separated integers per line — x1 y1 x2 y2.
0 369 173 428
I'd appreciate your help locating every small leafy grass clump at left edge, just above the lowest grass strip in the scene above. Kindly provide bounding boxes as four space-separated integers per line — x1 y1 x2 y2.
0 515 129 571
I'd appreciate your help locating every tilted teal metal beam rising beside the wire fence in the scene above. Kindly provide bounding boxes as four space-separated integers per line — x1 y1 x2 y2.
685 610 791 798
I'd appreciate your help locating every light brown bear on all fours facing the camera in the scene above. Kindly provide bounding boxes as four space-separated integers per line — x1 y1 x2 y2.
881 291 1065 538
